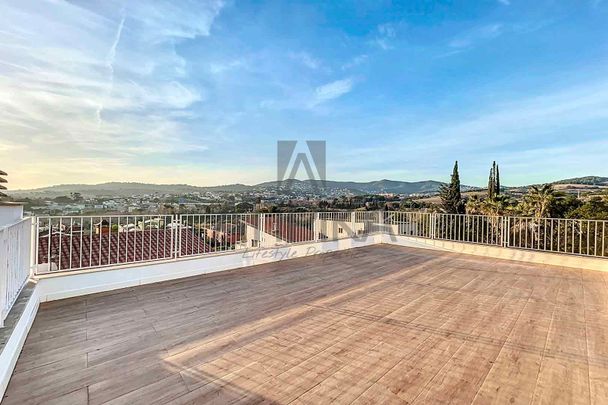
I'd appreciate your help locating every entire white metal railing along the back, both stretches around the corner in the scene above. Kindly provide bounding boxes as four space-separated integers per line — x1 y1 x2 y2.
35 211 608 274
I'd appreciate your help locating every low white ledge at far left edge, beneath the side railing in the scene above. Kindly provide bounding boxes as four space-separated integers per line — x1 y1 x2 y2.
0 283 40 401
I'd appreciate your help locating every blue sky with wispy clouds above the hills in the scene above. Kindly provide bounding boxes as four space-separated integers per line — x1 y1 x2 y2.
0 0 608 188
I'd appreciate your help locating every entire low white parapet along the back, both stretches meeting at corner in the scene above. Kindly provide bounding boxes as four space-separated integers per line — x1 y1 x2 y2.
30 229 608 302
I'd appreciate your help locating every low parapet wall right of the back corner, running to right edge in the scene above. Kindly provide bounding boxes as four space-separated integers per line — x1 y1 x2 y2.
383 235 608 271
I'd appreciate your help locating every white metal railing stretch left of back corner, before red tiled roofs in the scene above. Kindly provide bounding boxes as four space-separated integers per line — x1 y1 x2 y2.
34 212 381 274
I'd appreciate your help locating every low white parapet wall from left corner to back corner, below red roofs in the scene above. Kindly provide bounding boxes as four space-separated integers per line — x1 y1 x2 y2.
37 234 382 302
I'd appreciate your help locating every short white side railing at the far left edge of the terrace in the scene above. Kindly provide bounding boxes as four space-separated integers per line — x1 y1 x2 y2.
0 218 32 327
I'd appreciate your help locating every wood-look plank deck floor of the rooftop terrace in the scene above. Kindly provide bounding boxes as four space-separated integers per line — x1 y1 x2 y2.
3 245 608 405
